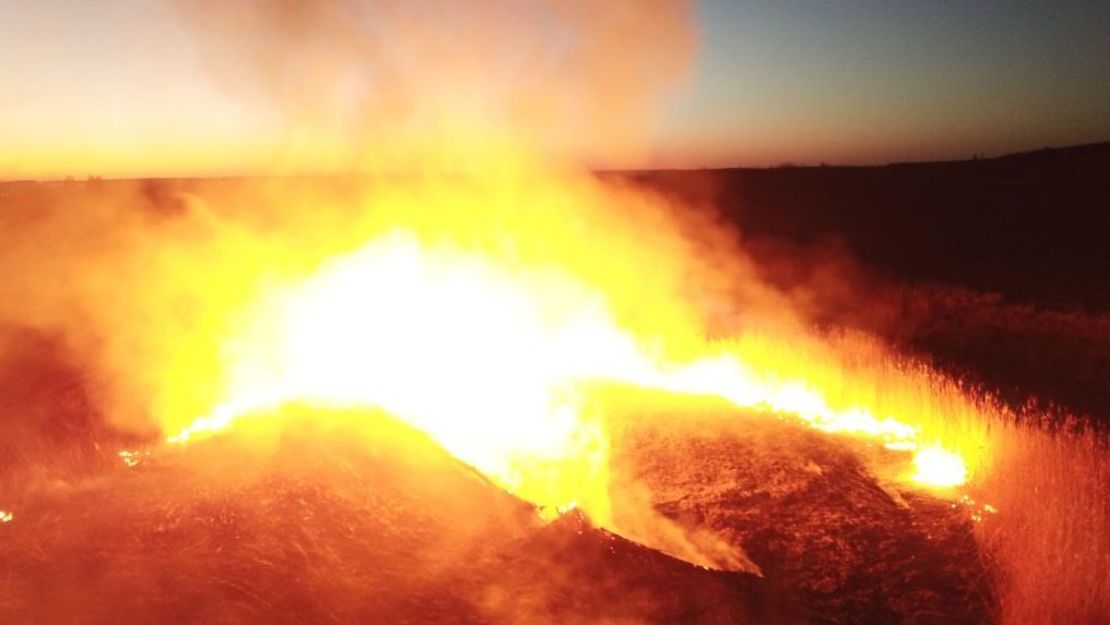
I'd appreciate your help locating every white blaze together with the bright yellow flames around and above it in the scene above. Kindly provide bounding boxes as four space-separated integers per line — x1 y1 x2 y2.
156 158 981 524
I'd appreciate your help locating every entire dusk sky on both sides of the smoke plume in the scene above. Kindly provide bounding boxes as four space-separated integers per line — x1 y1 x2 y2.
0 0 1110 179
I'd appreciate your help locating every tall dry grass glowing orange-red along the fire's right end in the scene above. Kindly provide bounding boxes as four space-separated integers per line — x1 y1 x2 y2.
799 333 1110 625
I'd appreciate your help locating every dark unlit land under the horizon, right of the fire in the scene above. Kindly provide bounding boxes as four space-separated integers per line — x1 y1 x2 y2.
630 142 1110 310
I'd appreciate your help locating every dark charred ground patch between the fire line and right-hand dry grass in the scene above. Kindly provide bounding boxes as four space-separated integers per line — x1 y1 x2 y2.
614 411 995 625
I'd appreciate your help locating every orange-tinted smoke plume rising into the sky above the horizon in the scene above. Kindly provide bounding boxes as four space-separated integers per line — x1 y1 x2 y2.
175 0 695 169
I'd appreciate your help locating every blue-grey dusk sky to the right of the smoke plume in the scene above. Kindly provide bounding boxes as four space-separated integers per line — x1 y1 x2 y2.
663 0 1110 164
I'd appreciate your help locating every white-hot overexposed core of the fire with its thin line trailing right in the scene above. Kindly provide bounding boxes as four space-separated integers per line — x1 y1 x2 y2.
164 229 967 518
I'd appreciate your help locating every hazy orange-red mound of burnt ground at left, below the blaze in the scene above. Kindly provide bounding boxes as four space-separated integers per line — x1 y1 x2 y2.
0 412 800 624
